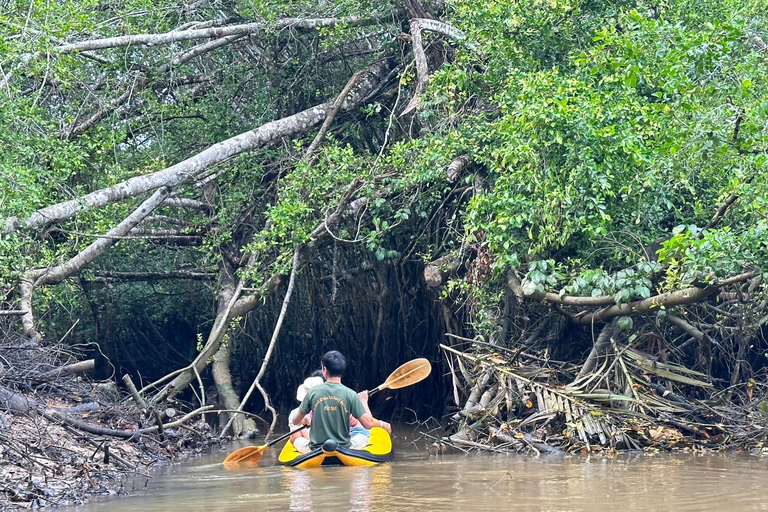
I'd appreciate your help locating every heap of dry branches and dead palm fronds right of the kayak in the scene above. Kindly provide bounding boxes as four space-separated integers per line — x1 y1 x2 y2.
430 330 768 454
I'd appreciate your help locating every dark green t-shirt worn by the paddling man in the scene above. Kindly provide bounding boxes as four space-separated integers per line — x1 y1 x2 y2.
299 382 365 449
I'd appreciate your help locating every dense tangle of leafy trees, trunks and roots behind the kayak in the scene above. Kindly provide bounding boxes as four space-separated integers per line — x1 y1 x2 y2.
0 0 768 447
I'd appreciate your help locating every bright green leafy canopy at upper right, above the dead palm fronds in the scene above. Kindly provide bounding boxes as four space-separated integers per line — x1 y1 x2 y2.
433 2 766 290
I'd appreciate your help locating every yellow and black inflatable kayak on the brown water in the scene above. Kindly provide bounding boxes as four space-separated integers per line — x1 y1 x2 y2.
278 427 395 469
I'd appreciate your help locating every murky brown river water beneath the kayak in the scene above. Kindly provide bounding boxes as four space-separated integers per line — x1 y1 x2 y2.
75 428 768 512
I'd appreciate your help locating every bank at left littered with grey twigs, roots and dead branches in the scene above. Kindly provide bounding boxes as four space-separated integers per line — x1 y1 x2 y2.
0 324 222 508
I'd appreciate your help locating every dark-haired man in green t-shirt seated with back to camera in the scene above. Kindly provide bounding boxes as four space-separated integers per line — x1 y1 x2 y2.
293 350 392 449
